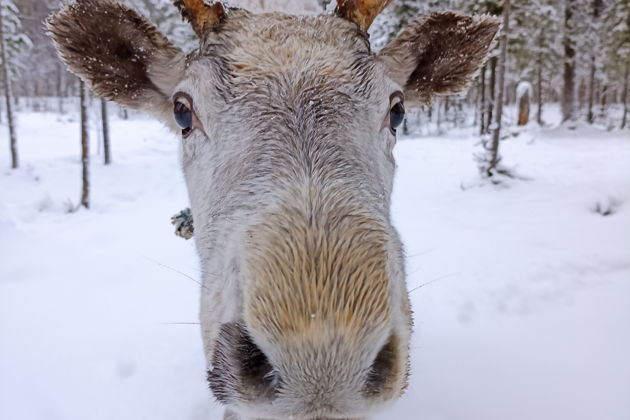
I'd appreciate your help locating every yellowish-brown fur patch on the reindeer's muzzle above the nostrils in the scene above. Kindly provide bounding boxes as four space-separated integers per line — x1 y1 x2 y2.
245 195 390 342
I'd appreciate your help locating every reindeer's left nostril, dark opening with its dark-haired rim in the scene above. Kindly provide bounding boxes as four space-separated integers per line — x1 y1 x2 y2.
208 322 279 404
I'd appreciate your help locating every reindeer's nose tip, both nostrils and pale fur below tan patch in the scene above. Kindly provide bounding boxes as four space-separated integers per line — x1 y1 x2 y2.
208 323 400 418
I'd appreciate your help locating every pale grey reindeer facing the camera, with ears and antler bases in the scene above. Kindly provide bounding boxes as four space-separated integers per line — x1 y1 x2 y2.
47 0 499 420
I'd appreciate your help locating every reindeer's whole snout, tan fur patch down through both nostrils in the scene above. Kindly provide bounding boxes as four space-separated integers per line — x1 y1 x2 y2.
208 207 408 420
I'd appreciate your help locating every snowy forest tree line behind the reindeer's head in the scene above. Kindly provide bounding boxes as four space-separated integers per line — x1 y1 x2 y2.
0 0 630 196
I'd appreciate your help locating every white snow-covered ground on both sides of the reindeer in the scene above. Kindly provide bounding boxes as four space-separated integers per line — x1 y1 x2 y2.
0 109 630 420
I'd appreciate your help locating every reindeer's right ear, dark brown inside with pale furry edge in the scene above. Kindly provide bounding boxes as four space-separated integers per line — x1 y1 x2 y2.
378 12 500 105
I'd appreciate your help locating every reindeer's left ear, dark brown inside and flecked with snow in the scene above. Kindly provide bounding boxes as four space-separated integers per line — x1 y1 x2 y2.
46 0 185 118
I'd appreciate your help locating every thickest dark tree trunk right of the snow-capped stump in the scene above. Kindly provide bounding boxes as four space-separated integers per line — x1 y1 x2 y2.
562 0 575 122
